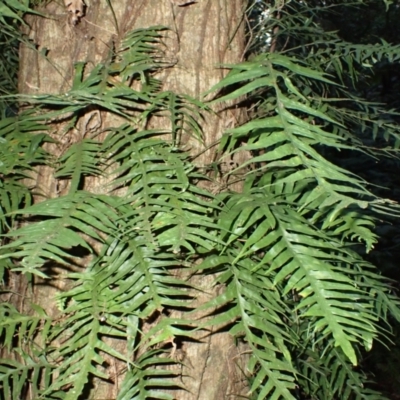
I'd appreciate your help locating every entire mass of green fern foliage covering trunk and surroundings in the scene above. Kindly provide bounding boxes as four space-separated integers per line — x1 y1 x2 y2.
0 0 400 400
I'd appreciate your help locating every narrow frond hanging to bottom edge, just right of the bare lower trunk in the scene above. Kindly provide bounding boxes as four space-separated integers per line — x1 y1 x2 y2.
198 254 296 400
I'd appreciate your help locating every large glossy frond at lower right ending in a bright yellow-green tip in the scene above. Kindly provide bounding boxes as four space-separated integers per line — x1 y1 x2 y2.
216 192 388 364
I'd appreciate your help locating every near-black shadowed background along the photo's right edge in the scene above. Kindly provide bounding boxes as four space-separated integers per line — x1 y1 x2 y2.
268 0 400 399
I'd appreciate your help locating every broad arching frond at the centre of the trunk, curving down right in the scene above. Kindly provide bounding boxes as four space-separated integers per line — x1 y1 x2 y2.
104 125 218 254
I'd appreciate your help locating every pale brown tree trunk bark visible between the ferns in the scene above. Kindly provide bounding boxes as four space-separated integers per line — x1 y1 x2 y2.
15 0 247 400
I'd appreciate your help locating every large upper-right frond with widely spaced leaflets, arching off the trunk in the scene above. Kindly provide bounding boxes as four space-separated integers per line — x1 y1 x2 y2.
214 55 386 220
